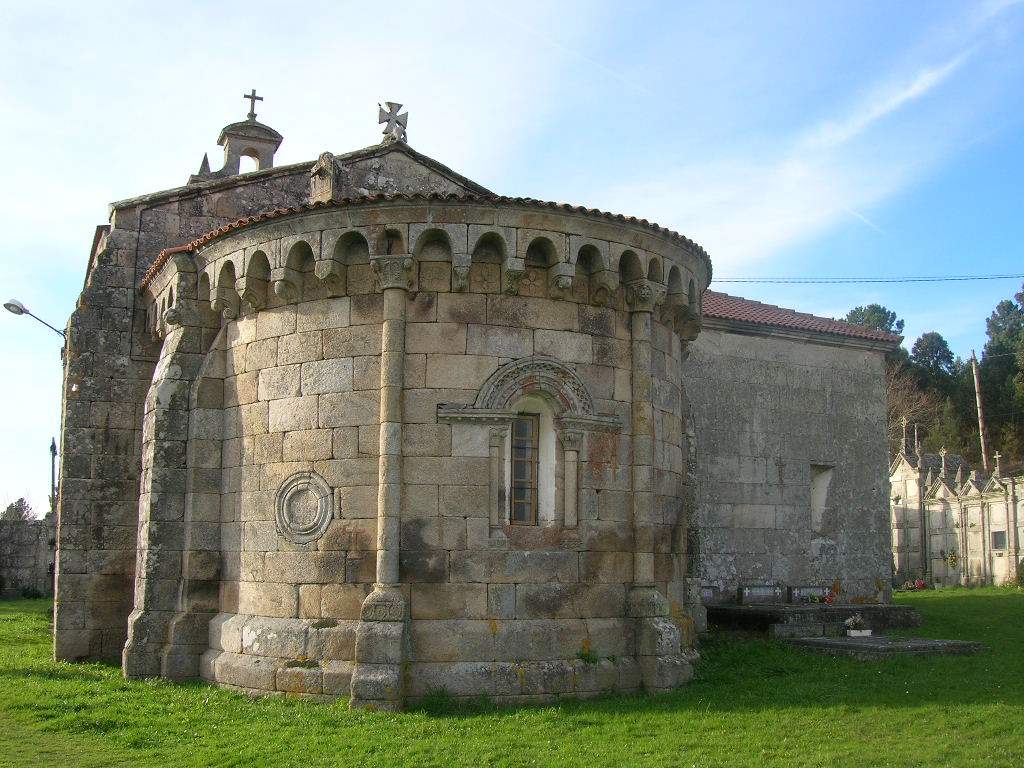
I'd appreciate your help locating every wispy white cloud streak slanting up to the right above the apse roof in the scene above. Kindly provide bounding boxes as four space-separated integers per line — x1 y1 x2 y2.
598 13 1007 275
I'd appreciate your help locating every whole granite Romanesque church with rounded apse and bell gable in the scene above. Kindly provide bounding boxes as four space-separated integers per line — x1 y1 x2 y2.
54 93 899 709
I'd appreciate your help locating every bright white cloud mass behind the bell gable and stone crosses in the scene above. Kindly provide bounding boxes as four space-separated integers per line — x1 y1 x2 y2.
0 0 595 510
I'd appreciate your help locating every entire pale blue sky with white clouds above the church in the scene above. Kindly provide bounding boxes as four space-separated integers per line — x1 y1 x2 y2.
0 0 1024 518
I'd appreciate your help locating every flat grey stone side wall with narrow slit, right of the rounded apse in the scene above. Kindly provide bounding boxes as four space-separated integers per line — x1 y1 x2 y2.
684 323 892 601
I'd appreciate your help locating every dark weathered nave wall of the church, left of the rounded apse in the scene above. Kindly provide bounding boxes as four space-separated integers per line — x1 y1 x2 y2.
54 163 311 660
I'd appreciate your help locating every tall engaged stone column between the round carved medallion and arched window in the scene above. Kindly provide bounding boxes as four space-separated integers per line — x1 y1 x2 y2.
350 249 413 710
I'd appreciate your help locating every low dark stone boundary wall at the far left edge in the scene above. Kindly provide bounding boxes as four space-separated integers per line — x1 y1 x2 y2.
0 515 56 597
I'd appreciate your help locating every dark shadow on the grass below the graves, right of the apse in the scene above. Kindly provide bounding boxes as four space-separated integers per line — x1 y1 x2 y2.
415 589 1024 722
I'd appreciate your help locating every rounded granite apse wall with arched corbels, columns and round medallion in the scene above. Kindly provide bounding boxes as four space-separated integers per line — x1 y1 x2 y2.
134 202 707 707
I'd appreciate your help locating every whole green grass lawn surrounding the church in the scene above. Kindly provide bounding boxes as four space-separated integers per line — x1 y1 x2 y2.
0 589 1024 768
